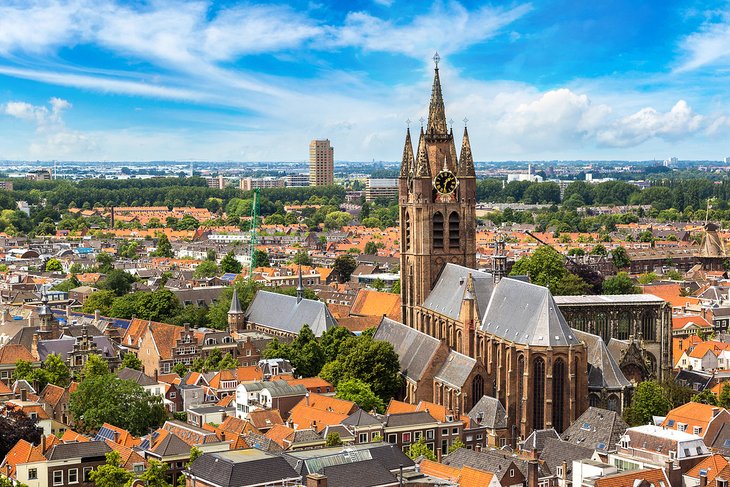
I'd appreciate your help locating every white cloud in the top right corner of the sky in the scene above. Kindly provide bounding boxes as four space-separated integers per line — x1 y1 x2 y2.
675 11 730 72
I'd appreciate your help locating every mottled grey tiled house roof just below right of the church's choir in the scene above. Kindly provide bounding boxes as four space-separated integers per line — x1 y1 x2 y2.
562 407 629 452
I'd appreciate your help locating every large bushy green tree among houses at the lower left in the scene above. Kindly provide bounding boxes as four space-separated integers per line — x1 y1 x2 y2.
69 373 167 436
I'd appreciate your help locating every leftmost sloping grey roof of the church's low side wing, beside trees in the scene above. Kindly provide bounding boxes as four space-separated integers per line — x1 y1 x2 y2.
373 318 441 381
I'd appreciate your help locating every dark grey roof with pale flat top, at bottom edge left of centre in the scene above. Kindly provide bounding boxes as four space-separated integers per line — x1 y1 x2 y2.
190 449 301 487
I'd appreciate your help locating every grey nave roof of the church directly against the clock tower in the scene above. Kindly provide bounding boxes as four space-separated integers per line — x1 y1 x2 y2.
423 263 494 319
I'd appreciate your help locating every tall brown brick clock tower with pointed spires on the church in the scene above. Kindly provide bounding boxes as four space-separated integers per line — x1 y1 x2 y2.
398 54 476 327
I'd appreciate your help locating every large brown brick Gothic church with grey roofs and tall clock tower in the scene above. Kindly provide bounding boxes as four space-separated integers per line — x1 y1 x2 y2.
376 56 588 440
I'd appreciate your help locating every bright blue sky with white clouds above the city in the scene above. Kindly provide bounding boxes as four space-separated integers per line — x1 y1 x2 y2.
0 0 730 161
